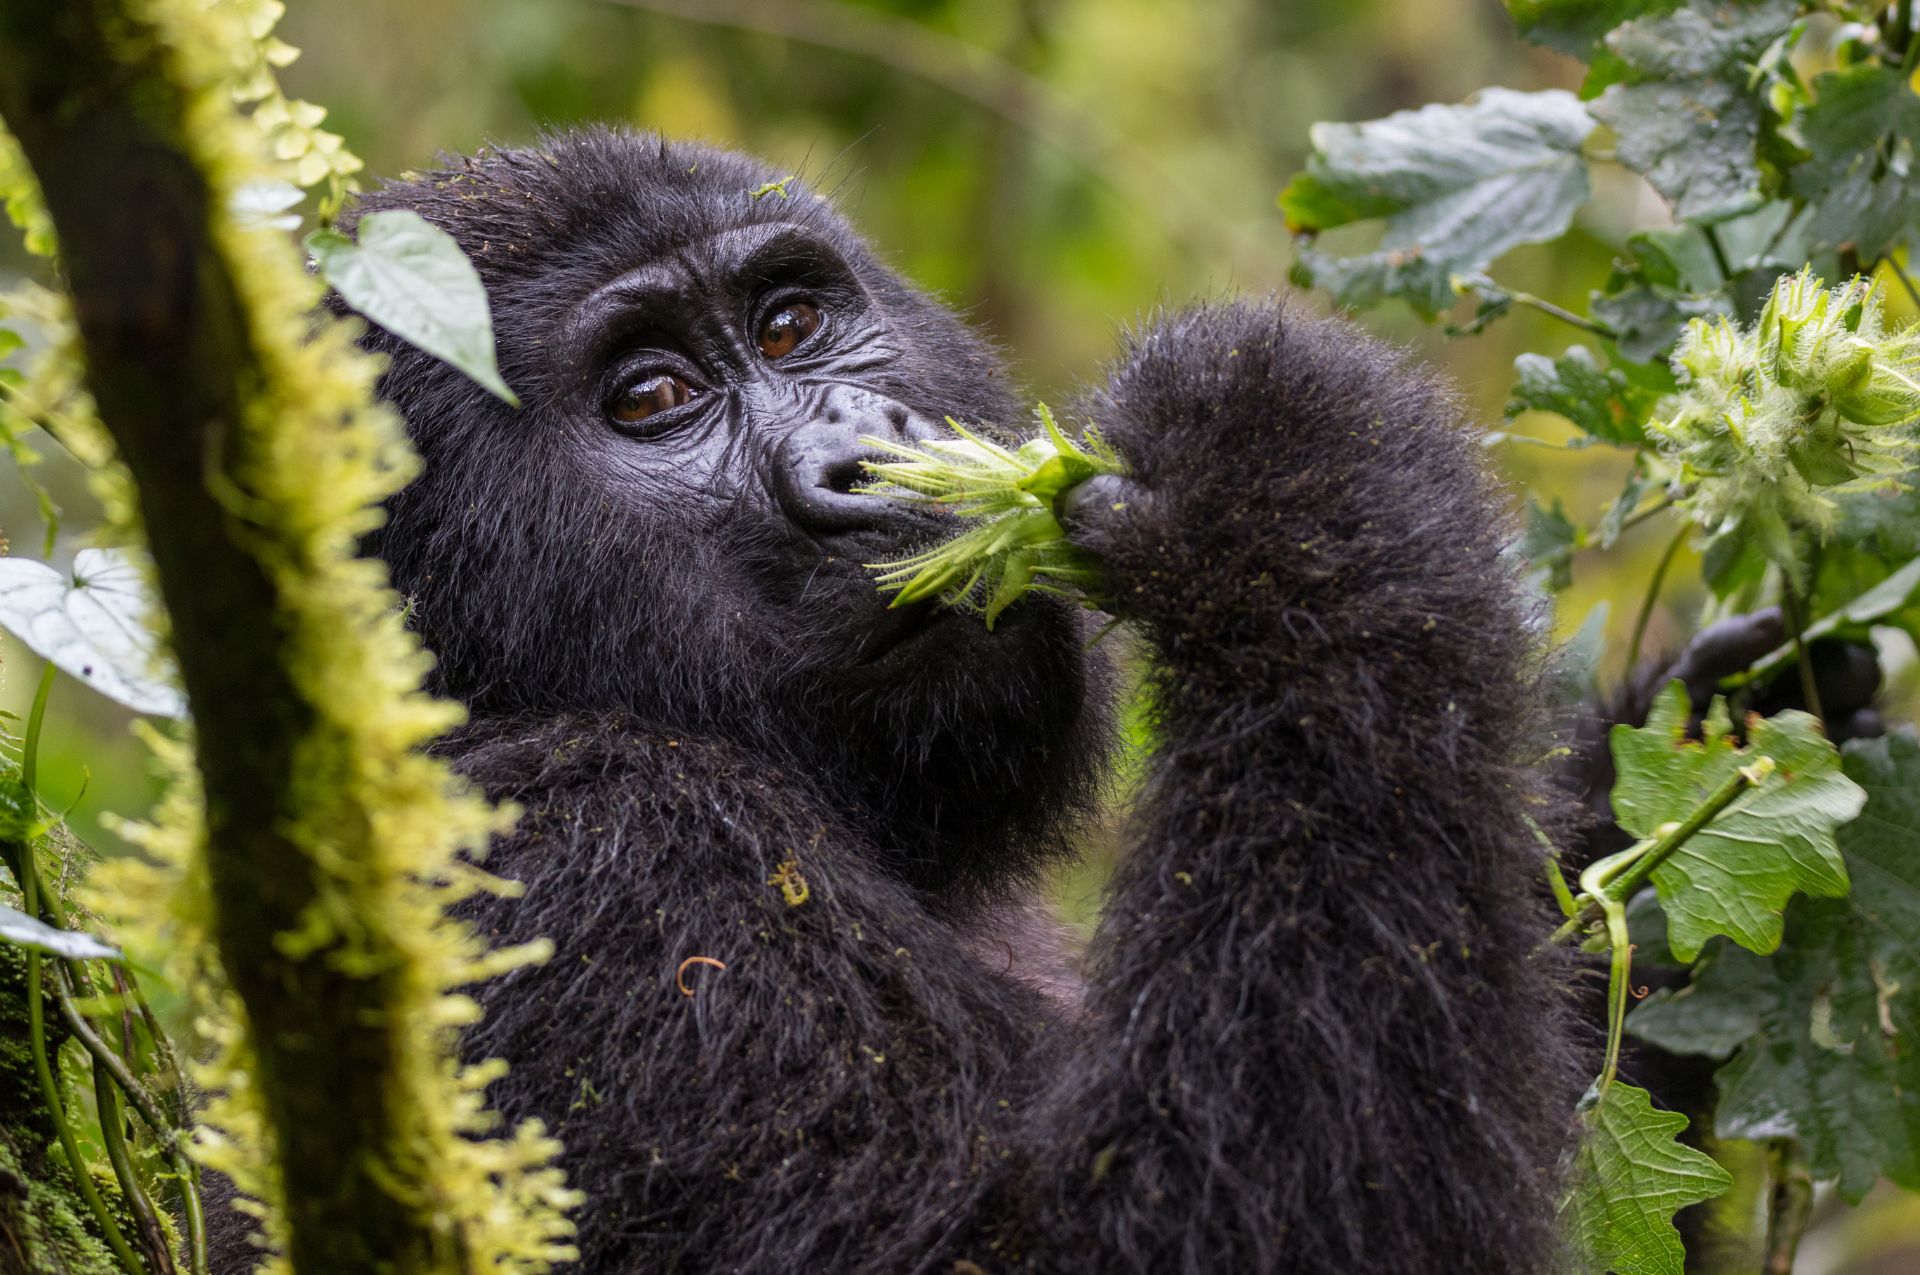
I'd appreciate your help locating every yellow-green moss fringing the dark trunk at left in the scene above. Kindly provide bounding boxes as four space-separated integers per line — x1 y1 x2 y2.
3 0 576 1271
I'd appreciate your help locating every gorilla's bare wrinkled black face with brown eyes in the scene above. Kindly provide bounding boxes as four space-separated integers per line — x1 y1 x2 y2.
555 223 1044 687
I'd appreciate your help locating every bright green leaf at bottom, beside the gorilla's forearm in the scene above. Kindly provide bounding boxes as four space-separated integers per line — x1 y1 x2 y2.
1561 1081 1734 1275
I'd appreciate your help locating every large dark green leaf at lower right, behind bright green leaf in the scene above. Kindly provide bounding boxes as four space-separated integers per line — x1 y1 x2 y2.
1628 734 1920 1200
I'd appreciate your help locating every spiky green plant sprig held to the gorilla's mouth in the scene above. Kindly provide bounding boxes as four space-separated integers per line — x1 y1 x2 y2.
860 403 1127 628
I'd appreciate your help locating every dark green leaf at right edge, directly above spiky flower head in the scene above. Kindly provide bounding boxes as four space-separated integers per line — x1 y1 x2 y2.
1791 65 1920 259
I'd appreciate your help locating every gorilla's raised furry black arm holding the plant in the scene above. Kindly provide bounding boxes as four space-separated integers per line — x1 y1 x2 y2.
1035 305 1578 1273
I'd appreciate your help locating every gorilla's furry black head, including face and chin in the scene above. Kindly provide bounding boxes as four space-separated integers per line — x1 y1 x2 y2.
357 131 1106 887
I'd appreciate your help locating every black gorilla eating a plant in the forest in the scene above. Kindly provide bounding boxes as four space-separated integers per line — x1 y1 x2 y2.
288 131 1578 1275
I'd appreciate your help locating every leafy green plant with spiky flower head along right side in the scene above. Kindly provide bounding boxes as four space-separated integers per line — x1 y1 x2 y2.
1279 0 1920 1275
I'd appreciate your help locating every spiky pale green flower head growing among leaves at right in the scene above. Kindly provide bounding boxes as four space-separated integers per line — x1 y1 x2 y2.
1649 269 1920 563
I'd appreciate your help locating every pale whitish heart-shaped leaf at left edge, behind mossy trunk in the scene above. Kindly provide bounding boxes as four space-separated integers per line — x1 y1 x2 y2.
0 549 186 718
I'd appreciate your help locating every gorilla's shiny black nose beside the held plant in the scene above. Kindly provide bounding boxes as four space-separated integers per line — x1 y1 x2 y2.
774 386 933 536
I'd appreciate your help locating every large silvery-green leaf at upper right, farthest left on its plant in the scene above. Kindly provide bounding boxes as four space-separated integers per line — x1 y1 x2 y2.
1281 88 1594 315
